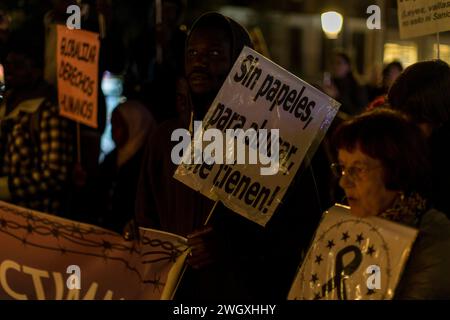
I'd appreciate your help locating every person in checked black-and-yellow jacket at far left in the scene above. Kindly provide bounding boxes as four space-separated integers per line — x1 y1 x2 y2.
0 27 74 214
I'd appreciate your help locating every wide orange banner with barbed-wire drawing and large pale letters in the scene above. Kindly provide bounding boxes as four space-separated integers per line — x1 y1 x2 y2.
0 202 189 300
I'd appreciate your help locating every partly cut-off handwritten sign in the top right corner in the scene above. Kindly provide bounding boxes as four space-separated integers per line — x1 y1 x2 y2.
397 0 450 39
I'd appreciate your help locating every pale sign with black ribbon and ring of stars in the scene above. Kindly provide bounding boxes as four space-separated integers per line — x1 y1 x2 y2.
288 205 417 300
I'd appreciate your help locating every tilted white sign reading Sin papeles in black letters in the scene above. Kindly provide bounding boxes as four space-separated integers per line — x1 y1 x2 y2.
172 47 340 226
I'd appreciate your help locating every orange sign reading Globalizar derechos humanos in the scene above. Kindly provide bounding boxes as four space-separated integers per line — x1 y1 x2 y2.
56 25 100 128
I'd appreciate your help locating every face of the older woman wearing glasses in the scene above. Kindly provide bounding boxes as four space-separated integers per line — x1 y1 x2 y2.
338 148 398 217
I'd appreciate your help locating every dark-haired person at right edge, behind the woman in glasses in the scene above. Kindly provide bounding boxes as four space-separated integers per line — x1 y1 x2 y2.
388 60 450 216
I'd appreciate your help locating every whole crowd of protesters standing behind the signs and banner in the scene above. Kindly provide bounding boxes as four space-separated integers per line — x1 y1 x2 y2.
0 0 450 300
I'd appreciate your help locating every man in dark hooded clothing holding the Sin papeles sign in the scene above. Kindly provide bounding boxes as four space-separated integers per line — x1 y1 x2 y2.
136 13 328 301
